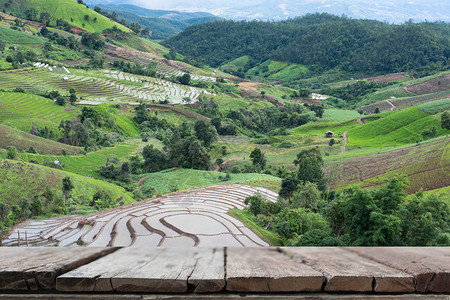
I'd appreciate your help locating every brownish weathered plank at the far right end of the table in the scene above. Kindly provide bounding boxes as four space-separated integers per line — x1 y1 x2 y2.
348 247 450 293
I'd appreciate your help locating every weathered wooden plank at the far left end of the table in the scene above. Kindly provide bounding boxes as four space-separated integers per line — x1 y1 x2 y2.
0 247 116 290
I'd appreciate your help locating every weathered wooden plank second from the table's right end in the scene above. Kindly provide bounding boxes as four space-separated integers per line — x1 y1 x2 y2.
282 247 414 293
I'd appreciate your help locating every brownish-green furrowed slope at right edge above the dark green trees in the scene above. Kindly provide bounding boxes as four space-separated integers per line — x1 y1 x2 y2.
325 137 450 193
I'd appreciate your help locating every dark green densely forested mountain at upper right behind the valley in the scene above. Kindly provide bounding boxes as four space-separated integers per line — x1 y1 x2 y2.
165 14 450 73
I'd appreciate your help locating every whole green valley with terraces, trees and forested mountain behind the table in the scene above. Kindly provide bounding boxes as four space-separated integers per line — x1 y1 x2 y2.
0 0 450 247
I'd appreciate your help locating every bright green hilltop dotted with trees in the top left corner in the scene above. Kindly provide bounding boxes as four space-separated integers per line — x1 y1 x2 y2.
0 0 129 32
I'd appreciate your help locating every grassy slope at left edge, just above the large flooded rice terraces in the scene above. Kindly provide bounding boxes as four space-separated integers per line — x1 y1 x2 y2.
0 160 134 203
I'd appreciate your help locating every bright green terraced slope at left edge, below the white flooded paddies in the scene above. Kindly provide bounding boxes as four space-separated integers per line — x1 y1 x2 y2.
0 92 79 137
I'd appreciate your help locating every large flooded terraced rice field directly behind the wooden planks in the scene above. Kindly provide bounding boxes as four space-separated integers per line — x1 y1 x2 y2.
3 184 278 247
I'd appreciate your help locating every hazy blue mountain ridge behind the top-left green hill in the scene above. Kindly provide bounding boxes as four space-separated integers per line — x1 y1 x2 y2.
92 4 220 40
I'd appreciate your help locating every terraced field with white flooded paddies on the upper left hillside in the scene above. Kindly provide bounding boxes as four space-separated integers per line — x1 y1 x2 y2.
0 65 202 104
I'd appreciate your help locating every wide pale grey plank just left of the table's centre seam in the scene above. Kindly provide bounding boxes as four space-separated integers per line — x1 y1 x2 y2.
56 248 225 293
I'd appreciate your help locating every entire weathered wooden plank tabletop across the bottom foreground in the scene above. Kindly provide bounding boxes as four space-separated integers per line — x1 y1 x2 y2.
0 247 450 300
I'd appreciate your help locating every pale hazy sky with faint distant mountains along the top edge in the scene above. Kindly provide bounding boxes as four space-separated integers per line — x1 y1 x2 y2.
88 0 450 24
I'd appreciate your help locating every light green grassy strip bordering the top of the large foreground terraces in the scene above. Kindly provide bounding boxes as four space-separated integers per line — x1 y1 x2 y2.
139 169 281 195
